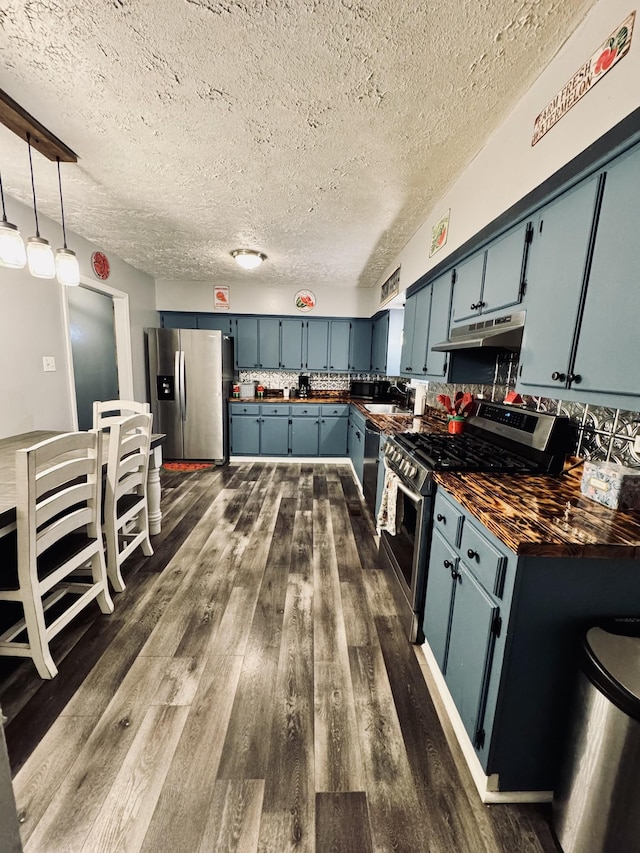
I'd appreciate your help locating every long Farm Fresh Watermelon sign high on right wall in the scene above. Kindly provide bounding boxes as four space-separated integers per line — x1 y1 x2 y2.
531 12 636 145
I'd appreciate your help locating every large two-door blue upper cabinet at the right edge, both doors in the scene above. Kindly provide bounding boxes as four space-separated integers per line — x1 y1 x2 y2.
518 140 640 410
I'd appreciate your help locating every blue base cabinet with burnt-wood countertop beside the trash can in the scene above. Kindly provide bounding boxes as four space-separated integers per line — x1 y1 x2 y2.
422 472 640 802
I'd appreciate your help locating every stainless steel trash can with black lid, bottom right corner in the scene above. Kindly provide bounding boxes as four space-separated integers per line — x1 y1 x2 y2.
552 618 640 853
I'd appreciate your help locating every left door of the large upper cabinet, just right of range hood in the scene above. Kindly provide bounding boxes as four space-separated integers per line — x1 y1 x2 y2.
519 176 598 395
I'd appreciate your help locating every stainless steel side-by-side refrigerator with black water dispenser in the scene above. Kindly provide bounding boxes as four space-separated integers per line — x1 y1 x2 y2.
145 329 233 463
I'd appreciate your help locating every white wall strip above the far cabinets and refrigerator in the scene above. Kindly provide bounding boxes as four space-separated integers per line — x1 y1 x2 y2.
156 273 371 317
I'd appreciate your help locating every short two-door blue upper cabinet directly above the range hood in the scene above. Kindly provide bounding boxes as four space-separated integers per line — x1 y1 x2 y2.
451 222 532 325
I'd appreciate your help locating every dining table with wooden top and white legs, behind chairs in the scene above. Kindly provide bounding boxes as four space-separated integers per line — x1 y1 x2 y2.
0 430 165 536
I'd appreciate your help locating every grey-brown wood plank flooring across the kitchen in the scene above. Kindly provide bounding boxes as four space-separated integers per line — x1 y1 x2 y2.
0 462 557 853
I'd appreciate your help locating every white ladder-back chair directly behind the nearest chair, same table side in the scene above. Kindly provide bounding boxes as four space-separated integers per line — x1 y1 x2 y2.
104 413 153 592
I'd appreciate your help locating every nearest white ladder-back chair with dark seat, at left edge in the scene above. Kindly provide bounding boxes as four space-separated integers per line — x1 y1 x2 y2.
0 430 113 678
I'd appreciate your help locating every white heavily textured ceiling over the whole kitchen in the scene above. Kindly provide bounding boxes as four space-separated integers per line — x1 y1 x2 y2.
0 0 595 287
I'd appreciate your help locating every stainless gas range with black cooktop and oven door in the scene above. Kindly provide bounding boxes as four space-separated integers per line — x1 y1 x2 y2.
380 401 573 643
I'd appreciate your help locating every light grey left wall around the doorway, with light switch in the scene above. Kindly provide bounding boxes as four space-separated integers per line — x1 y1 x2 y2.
0 196 158 438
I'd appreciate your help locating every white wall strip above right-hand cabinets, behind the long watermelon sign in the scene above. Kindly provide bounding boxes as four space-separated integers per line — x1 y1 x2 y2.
398 0 640 290
